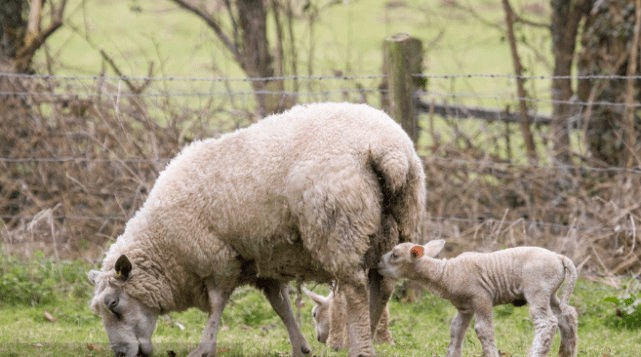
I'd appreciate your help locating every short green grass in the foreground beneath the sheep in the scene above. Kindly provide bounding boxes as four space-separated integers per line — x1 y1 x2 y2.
0 255 641 357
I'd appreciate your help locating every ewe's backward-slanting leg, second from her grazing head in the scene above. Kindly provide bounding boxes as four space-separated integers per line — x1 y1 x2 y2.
257 279 312 357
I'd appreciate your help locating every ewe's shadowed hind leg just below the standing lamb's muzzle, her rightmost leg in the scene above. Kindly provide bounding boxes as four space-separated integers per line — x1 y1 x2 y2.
368 269 394 343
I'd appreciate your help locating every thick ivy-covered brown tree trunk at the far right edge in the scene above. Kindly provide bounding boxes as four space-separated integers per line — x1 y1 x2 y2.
577 0 641 166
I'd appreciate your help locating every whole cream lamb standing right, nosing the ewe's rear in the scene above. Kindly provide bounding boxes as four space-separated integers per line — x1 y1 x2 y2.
378 240 578 357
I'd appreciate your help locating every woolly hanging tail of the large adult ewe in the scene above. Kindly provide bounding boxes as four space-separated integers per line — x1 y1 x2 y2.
370 148 426 242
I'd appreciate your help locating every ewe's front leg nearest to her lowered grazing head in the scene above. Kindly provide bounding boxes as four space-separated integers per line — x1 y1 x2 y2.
187 287 232 357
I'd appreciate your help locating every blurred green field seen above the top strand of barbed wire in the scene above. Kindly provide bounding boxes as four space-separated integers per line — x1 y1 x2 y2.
35 0 551 97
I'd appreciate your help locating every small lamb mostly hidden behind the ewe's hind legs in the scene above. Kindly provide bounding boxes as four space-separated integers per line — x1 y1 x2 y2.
303 285 394 350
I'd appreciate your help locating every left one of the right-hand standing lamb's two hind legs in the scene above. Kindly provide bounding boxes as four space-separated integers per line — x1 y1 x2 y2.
526 296 557 357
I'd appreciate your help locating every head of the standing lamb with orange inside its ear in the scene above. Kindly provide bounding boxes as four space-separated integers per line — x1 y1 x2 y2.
378 239 445 279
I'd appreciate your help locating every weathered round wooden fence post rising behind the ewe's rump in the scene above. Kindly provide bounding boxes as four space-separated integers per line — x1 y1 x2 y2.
383 33 425 143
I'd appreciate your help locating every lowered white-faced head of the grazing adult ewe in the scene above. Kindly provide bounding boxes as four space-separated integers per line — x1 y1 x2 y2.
88 255 159 357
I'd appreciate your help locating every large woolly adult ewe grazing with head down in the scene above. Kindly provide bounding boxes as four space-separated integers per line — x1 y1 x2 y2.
89 103 425 357
